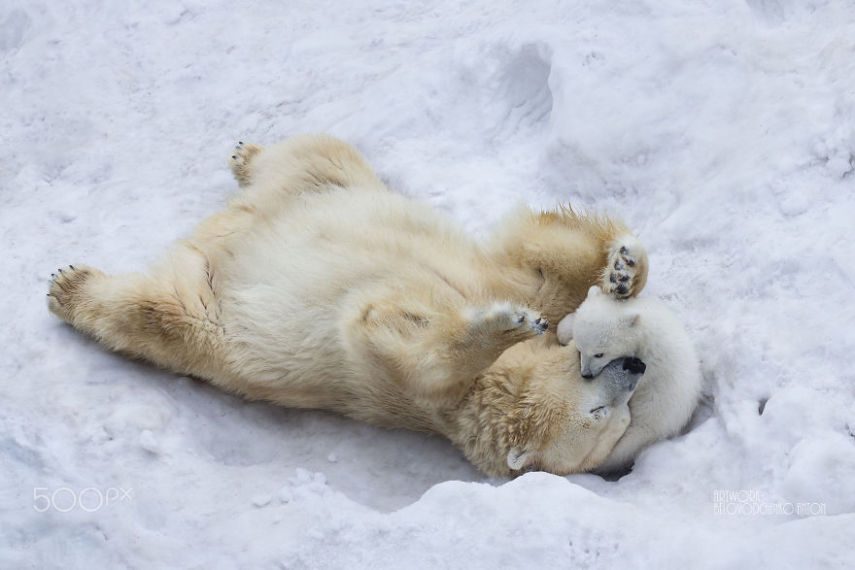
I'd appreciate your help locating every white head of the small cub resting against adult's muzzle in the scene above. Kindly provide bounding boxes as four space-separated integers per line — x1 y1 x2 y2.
558 286 640 378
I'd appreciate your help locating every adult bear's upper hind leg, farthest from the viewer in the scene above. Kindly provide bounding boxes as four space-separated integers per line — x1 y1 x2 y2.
229 135 386 200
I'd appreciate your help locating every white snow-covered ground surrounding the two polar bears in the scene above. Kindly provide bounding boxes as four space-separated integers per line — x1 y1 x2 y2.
0 0 855 569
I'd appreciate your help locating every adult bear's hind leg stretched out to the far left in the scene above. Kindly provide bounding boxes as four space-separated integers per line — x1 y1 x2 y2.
48 252 222 377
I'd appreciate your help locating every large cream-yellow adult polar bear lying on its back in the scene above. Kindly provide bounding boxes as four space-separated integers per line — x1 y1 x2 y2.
48 136 647 474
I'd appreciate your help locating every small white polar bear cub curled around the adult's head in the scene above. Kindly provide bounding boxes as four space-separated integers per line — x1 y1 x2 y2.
557 287 701 472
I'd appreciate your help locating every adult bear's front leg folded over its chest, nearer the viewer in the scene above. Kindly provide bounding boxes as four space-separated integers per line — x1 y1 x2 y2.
360 302 548 400
